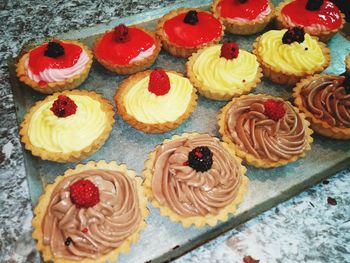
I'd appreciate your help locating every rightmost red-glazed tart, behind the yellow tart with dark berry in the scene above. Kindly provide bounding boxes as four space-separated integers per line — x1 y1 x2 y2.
276 0 345 42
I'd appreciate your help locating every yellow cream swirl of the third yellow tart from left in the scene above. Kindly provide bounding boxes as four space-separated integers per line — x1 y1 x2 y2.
192 45 259 93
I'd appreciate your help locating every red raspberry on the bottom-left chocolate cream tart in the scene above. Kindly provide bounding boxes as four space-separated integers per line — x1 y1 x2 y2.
69 179 100 208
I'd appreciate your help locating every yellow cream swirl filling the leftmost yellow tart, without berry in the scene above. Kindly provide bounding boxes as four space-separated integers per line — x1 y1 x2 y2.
28 95 106 153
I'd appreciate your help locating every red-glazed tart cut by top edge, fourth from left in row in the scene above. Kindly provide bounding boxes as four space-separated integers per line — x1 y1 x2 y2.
211 0 274 35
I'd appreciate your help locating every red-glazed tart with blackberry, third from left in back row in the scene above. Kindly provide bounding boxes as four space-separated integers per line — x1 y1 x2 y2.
157 8 224 58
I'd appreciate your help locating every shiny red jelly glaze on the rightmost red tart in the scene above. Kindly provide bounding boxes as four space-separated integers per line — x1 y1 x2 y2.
281 0 342 29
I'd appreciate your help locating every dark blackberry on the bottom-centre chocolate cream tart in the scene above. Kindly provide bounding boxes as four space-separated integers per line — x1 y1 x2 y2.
188 146 213 172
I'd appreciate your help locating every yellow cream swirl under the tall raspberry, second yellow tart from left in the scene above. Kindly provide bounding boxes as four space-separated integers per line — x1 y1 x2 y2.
124 72 193 124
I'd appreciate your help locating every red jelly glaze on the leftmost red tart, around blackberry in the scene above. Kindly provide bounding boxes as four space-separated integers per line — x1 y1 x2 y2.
28 40 82 75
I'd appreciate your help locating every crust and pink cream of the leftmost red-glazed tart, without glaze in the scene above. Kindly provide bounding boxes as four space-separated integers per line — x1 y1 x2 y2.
16 40 93 94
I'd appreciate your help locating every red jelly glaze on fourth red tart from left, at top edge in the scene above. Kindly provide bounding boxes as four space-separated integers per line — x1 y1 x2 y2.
217 0 269 20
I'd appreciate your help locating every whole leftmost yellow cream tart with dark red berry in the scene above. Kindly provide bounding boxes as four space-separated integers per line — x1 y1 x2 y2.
20 90 114 163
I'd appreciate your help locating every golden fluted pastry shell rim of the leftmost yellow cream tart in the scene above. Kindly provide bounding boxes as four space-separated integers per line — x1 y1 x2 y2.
19 90 114 163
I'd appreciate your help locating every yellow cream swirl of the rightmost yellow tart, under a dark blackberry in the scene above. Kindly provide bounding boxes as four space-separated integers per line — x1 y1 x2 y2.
258 29 326 73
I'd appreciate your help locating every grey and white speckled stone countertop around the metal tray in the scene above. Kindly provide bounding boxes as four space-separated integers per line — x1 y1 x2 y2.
0 0 350 263
